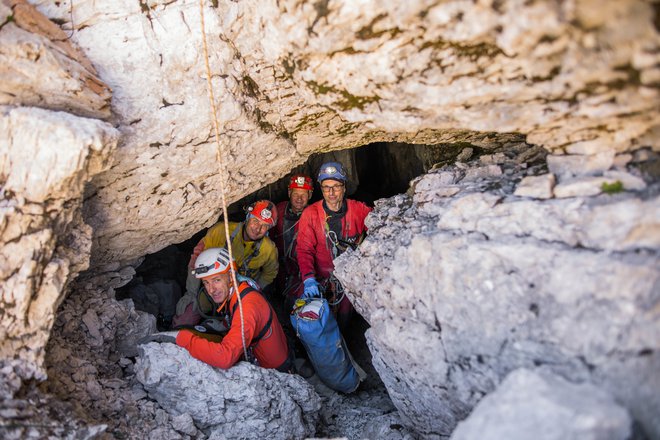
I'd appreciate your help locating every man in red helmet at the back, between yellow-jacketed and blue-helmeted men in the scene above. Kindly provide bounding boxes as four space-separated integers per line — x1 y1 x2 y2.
272 174 314 302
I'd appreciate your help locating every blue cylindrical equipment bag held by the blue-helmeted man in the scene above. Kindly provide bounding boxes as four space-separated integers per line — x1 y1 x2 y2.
291 298 360 393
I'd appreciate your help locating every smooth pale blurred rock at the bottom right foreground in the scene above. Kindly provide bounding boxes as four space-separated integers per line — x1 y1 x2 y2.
451 369 631 440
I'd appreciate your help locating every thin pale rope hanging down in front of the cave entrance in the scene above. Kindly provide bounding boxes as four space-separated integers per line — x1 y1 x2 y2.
199 0 250 361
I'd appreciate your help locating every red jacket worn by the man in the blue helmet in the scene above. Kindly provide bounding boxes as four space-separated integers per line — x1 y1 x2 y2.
296 199 372 280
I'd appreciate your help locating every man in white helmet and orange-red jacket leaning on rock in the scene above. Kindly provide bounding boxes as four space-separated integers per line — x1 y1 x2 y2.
176 248 293 372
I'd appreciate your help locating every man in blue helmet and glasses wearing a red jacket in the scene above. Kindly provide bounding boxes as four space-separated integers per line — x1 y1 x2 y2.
296 162 371 333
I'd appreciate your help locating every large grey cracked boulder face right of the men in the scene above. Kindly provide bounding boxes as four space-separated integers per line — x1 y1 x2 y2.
336 148 660 437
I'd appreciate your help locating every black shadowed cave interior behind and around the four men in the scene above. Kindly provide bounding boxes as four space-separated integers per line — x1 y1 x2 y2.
116 139 490 388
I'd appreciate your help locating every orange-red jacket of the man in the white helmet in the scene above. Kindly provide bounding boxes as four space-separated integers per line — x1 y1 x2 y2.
176 282 289 369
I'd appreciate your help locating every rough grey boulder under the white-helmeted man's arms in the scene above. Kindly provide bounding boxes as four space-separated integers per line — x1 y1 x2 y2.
135 343 320 439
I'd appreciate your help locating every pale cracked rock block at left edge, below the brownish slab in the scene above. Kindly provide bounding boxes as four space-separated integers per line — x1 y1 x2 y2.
0 107 118 377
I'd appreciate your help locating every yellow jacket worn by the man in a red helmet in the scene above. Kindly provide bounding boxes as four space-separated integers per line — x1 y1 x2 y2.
202 222 279 289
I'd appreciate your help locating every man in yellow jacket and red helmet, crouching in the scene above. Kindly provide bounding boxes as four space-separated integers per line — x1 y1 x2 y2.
172 200 279 327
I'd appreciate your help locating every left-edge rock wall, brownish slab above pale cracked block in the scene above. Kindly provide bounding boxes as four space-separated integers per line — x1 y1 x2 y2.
0 0 119 379
